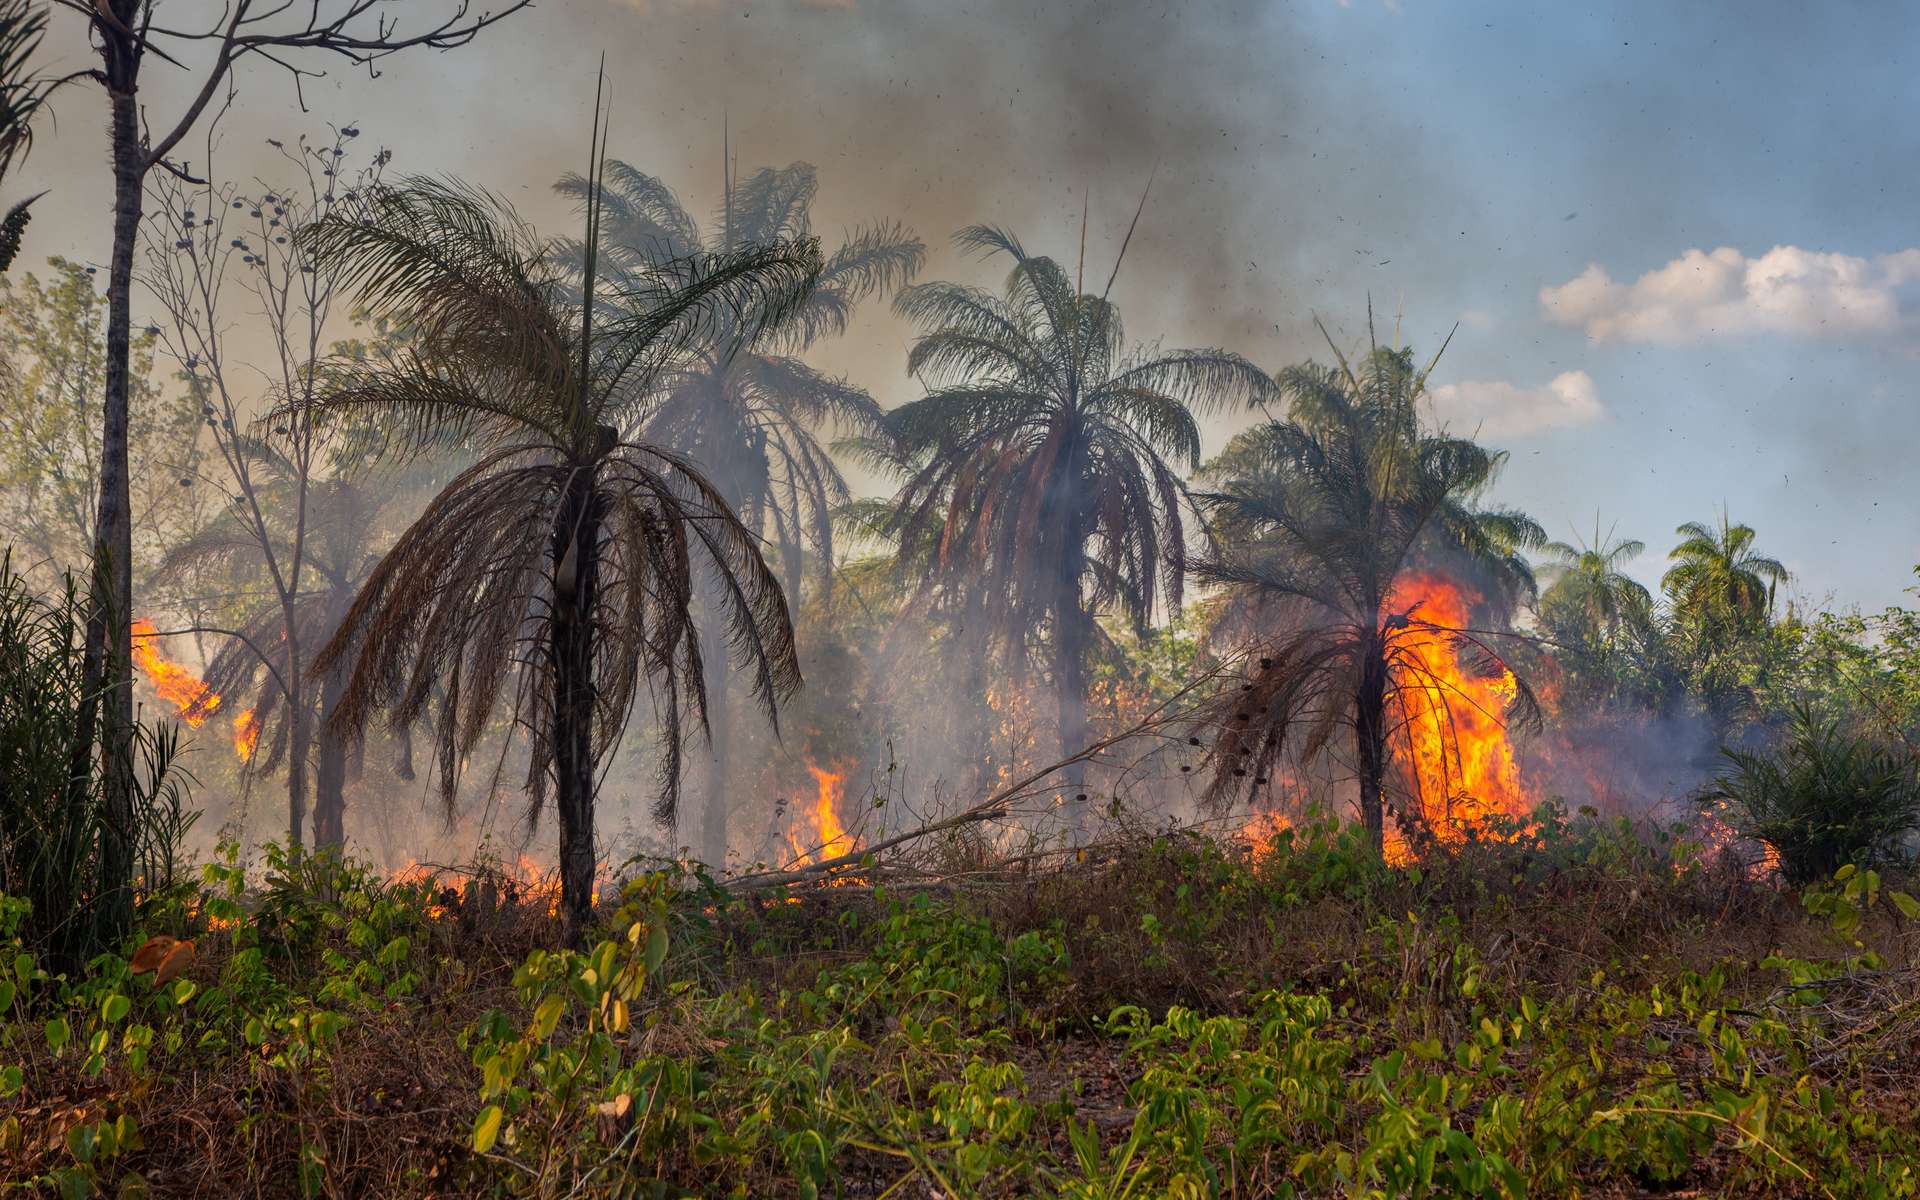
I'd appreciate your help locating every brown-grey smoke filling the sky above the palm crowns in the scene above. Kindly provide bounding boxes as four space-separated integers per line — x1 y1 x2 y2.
18 0 1457 399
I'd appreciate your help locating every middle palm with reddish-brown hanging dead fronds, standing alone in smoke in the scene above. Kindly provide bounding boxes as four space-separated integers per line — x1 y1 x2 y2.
881 225 1273 806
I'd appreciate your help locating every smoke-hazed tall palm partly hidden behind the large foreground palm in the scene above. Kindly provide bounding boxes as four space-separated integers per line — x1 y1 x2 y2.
557 161 925 868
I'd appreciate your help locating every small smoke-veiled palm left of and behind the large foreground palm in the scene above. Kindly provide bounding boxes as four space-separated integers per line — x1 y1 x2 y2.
159 453 386 847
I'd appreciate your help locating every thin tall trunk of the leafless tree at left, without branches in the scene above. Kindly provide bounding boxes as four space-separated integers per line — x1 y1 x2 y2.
73 79 146 935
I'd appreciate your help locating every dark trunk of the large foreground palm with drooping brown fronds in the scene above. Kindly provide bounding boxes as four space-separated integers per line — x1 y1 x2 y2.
549 467 599 943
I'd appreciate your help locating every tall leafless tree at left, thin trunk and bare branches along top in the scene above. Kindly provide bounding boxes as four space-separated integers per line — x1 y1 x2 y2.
48 0 532 922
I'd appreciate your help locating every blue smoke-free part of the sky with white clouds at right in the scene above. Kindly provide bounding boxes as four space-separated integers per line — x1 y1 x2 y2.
1313 0 1920 605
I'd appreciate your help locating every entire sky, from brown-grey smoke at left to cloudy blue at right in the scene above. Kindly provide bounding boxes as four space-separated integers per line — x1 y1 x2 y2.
27 0 1920 607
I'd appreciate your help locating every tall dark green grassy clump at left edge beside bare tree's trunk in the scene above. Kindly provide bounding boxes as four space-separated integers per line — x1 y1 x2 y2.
0 555 192 964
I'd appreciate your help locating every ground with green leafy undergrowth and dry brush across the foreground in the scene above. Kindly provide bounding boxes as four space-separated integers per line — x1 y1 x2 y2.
0 816 1920 1200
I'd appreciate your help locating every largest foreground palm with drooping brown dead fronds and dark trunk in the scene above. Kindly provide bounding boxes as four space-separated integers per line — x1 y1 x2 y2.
289 168 820 937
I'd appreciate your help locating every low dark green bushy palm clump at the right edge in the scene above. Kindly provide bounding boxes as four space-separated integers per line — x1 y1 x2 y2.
1703 707 1920 887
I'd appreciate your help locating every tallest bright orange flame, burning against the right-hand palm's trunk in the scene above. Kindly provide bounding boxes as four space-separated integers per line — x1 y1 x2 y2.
1386 572 1532 862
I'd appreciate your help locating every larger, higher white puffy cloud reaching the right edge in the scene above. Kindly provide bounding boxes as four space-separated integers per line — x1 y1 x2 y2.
1540 246 1920 342
